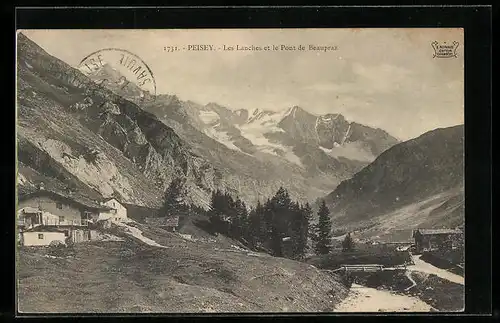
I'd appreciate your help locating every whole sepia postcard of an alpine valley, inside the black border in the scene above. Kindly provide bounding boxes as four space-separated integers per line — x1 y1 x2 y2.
15 28 466 314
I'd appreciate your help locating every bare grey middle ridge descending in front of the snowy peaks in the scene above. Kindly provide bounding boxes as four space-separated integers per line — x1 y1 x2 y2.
143 95 345 204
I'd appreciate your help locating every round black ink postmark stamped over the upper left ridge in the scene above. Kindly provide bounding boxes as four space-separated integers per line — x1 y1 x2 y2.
78 48 156 103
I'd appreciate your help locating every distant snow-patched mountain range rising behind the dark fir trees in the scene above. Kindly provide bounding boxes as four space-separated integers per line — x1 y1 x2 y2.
141 95 397 203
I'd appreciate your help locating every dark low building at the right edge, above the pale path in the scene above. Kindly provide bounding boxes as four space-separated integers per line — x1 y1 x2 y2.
412 229 463 253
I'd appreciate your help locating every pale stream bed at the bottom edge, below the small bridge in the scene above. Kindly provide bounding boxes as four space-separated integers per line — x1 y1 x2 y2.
334 284 432 312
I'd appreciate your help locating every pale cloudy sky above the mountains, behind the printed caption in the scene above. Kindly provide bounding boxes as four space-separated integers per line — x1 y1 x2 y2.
21 28 464 140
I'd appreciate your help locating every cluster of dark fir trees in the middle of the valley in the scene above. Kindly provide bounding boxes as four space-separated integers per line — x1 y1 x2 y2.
160 179 340 259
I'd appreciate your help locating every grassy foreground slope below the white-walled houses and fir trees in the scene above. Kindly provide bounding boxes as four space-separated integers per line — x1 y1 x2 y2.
17 226 347 313
